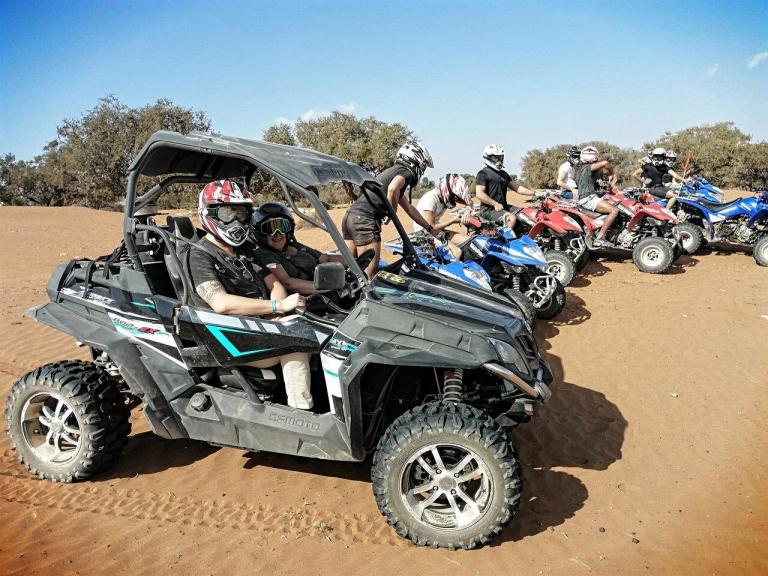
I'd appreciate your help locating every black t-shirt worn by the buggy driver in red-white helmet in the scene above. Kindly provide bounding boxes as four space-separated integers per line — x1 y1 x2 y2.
184 238 270 298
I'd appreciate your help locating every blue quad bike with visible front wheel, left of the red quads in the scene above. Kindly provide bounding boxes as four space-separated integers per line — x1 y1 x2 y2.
387 228 565 320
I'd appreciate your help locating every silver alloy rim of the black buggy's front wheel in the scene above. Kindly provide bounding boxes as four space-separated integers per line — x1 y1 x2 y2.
400 443 493 530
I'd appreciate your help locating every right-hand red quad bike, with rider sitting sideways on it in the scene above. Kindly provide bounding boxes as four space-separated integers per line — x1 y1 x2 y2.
543 189 682 274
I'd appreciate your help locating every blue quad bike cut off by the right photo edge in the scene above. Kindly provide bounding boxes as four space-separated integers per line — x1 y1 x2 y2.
640 190 768 266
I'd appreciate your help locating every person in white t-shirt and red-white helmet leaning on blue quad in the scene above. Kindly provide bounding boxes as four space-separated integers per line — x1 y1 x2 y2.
413 174 472 258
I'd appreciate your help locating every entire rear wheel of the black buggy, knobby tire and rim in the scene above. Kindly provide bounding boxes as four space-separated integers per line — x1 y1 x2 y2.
5 360 131 482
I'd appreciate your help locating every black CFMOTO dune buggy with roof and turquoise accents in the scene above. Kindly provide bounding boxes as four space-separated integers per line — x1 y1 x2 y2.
6 131 552 548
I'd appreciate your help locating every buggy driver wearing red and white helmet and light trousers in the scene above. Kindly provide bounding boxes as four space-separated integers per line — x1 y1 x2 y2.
187 180 313 410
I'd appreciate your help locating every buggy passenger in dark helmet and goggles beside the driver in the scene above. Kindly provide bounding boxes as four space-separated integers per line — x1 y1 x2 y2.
251 202 344 295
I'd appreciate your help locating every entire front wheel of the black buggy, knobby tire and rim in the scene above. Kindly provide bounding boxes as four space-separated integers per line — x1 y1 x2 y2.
371 402 523 549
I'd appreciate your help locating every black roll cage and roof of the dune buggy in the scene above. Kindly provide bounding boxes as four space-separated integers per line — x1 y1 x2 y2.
123 130 420 304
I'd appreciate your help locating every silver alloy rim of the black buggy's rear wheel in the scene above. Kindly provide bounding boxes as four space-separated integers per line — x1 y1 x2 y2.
21 392 82 464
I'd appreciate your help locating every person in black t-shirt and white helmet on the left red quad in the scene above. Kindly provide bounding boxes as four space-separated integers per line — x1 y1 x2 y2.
475 144 533 230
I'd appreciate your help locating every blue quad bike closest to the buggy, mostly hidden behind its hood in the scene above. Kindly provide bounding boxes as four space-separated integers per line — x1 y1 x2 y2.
384 232 536 330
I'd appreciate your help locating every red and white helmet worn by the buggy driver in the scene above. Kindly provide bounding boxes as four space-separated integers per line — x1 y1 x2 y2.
197 180 253 246
